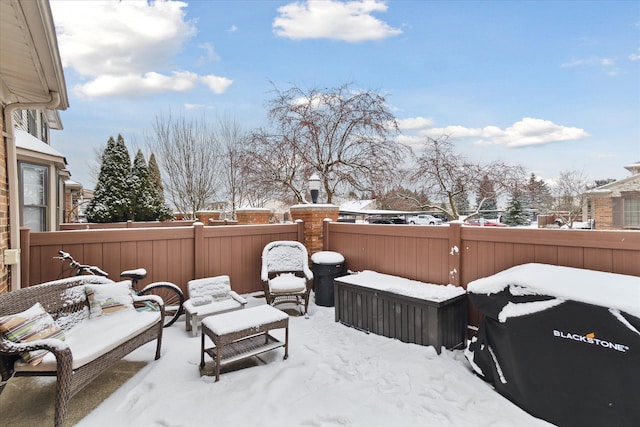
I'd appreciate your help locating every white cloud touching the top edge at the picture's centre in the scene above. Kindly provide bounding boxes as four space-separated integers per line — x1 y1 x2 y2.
273 0 402 43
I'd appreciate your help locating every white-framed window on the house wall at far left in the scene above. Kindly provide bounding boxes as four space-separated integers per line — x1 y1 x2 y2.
20 163 49 231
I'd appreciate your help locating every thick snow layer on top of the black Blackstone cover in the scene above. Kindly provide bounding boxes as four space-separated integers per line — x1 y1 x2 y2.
467 263 640 317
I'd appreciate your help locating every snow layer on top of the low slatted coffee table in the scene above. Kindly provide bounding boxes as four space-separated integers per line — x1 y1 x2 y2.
202 305 289 336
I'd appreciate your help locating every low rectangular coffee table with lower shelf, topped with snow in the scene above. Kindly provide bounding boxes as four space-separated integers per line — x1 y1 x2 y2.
200 305 289 381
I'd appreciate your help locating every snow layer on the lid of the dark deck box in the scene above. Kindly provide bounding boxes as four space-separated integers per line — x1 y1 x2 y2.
338 270 465 302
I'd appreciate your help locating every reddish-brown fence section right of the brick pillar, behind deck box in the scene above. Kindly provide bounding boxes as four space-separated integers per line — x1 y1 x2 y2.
324 222 640 325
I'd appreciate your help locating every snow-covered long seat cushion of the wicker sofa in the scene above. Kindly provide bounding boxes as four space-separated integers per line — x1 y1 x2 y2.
14 310 160 372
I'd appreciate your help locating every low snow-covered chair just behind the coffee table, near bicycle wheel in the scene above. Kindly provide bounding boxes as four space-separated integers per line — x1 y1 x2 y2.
183 275 247 336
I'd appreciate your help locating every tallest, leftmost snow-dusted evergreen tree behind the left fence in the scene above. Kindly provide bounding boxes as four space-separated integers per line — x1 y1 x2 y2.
86 135 131 222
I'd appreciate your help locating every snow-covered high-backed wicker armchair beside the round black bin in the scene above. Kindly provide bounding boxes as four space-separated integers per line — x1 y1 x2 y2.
261 240 313 315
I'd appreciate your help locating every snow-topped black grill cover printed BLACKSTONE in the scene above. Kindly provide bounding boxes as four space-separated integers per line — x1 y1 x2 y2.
466 264 640 426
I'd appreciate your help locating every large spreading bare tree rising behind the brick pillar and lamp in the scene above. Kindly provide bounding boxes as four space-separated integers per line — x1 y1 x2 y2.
244 84 405 203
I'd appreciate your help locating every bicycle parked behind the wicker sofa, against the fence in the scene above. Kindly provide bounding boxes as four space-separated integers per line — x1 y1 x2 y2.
54 251 184 328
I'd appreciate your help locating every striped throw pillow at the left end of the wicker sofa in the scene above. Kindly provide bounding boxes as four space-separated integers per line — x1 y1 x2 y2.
0 302 65 366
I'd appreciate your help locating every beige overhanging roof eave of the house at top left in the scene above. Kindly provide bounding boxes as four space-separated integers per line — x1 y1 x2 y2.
0 0 69 125
